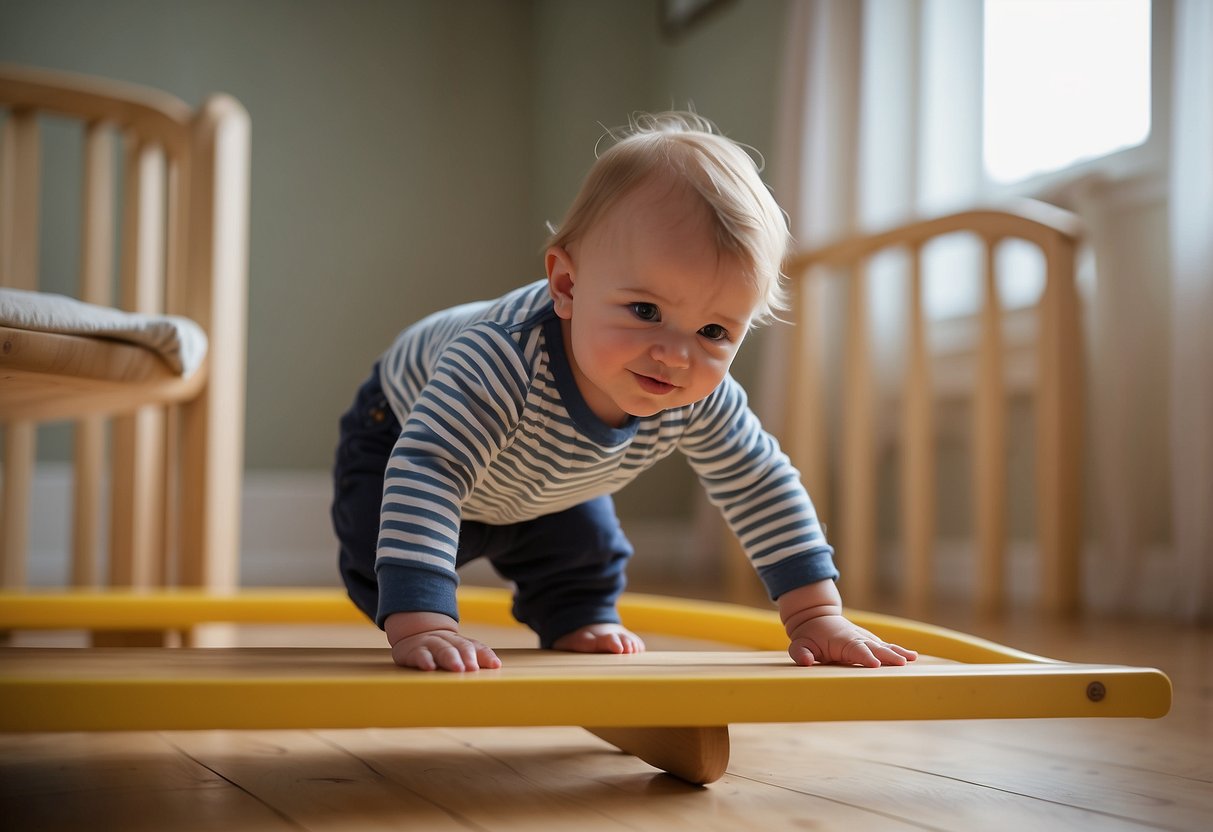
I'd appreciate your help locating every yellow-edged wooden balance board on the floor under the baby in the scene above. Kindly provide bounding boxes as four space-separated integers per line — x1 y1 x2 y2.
0 587 1171 783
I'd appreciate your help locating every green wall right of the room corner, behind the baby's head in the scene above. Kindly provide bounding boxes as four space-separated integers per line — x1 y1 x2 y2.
534 0 787 517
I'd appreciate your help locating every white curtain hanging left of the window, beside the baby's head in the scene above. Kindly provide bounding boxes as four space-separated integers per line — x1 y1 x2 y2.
763 0 981 421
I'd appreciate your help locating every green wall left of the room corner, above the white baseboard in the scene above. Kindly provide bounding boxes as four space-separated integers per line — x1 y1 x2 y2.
0 0 541 468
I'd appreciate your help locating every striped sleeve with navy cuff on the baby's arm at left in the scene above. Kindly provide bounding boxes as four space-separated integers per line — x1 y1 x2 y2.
375 324 530 627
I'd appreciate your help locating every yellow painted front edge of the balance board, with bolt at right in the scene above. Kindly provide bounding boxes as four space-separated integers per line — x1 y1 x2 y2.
0 665 1171 731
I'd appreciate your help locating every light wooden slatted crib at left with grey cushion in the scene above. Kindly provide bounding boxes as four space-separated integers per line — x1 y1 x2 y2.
0 65 250 599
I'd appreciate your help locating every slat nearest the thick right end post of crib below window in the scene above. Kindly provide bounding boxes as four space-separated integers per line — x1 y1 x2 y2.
973 238 1007 612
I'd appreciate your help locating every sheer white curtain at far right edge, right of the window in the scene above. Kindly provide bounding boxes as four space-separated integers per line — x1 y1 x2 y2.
1169 0 1213 623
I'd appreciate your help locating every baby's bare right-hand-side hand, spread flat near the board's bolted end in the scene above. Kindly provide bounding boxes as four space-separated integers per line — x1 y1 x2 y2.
779 580 918 667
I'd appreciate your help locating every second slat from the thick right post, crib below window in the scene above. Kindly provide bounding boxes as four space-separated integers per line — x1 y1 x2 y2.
900 246 935 615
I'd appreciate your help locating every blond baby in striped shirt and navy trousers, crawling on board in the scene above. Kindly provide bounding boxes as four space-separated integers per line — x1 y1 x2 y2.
332 113 917 671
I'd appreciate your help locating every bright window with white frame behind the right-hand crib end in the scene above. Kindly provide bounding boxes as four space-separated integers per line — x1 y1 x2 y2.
919 0 1169 320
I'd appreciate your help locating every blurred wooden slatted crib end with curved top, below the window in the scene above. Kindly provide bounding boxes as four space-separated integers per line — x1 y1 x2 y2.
761 201 1083 616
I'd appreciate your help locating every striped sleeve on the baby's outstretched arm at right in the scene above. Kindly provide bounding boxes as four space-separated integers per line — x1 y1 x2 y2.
679 377 838 600
